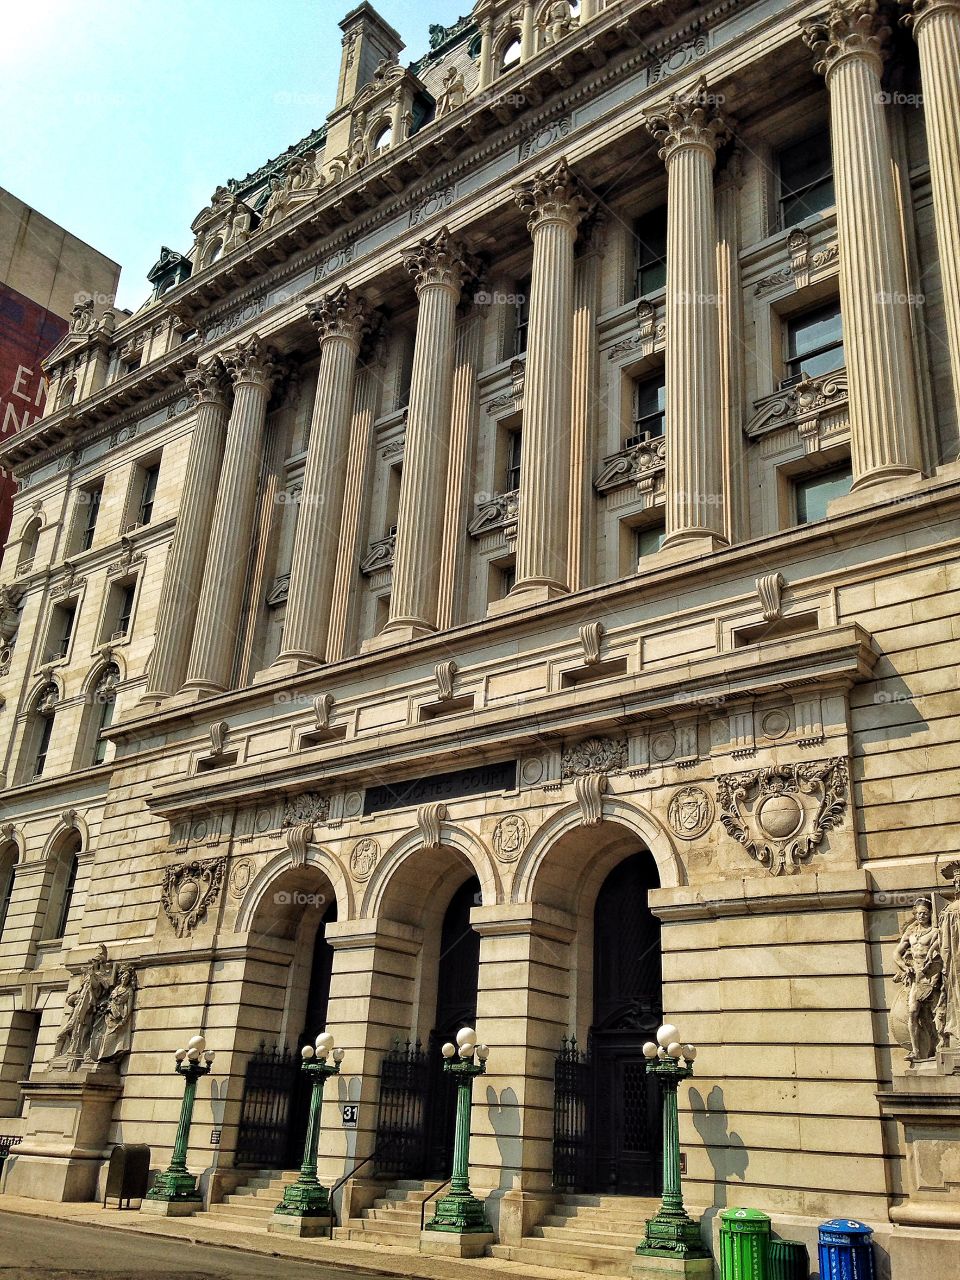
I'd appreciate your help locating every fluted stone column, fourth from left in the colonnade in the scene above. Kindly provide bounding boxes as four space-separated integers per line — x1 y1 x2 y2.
383 228 474 641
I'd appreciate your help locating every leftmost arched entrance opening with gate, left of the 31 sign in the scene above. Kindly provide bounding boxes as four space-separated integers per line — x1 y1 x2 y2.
236 867 337 1169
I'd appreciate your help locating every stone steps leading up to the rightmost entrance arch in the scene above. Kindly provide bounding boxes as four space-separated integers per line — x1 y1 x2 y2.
490 1196 660 1276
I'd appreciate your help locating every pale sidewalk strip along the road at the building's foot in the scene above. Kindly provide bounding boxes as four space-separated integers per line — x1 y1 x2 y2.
0 1196 584 1280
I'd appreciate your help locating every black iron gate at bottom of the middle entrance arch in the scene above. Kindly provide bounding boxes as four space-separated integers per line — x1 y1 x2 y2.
376 1041 430 1178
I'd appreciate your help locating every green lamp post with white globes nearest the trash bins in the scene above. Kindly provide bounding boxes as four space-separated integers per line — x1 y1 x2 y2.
636 1023 710 1258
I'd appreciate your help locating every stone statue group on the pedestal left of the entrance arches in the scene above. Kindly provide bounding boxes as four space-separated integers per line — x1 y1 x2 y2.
54 943 137 1064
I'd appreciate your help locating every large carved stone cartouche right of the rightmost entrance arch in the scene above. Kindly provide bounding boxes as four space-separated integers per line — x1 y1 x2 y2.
717 756 847 876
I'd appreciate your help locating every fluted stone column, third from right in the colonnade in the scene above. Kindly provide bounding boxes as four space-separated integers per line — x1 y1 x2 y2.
646 78 730 556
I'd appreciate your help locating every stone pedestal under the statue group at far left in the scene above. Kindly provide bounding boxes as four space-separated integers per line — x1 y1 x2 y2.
4 1064 123 1202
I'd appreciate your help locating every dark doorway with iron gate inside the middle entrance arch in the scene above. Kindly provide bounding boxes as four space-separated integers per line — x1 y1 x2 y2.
376 876 481 1179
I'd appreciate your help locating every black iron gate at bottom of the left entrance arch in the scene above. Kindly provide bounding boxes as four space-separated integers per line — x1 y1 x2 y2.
234 1042 301 1169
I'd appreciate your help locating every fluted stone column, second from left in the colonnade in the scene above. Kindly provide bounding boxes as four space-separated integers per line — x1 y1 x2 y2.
184 335 275 694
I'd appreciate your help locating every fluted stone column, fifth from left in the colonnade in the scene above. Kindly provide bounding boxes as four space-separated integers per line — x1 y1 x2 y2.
509 160 588 603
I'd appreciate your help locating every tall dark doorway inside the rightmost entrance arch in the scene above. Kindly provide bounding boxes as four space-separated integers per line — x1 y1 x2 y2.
588 852 663 1196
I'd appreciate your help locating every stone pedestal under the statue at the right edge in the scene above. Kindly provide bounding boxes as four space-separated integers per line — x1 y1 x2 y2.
877 1050 960 1228
